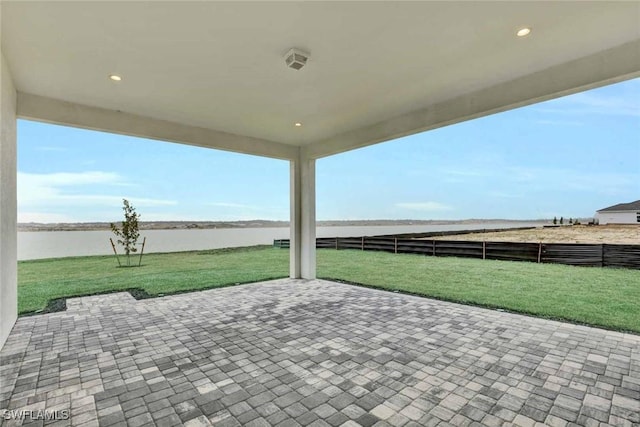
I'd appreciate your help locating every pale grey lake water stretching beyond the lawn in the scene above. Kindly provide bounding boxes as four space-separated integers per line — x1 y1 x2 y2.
18 222 540 260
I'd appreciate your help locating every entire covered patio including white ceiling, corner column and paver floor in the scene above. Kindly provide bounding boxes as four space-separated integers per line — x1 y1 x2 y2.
0 1 640 426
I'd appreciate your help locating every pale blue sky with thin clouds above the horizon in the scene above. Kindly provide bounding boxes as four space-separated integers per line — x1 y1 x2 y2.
18 79 640 222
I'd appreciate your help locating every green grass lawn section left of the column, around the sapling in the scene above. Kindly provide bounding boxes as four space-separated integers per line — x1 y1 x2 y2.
18 246 289 313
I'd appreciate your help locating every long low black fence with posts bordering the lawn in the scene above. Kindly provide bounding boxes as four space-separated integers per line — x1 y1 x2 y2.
273 236 640 269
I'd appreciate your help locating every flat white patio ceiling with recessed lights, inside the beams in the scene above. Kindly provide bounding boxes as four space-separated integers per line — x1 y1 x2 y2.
2 0 640 155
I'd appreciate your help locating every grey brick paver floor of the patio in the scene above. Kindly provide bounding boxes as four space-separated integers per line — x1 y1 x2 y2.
0 279 640 427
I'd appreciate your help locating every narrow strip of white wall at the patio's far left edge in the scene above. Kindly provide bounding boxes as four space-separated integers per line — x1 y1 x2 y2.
0 48 18 348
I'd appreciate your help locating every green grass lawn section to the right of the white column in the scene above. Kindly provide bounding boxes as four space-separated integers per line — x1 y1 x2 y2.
318 250 640 332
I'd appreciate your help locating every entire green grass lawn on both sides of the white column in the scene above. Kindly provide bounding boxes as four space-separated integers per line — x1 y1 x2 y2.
18 247 640 332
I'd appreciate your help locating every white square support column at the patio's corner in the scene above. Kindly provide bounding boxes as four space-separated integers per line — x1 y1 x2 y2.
289 150 316 279
